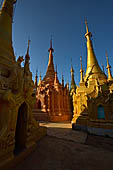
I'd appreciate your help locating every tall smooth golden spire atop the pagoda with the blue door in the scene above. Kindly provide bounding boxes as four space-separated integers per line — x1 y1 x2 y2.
85 21 106 80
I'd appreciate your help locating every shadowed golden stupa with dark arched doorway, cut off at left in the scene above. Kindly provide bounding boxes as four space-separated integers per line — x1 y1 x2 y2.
0 0 46 169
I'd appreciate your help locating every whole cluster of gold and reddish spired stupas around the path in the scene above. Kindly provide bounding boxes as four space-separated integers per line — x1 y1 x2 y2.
0 0 113 168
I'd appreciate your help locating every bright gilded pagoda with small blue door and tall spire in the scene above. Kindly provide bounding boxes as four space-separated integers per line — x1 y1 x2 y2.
72 22 113 137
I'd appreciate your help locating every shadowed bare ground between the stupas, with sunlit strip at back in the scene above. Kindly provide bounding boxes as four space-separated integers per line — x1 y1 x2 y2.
13 123 113 170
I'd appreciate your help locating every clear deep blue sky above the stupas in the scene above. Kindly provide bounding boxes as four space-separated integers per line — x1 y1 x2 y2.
2 0 113 85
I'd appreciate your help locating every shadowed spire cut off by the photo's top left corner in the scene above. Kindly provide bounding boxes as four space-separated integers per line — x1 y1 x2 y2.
0 0 16 62
